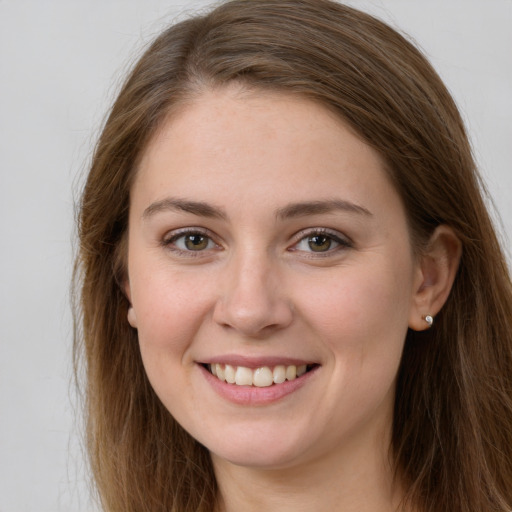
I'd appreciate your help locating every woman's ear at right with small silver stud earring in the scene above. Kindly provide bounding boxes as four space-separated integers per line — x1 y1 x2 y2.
409 225 462 331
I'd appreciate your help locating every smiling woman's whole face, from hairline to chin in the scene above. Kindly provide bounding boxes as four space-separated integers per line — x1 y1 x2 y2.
126 87 422 467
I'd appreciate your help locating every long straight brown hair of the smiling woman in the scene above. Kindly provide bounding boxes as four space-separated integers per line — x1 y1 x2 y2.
75 0 512 512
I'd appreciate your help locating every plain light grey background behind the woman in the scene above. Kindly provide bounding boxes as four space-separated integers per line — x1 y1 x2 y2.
0 0 512 512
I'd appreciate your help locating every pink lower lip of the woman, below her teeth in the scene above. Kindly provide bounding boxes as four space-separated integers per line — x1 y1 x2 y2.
198 365 319 405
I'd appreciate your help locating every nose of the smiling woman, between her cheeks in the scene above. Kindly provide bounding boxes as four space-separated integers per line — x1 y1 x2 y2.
213 253 293 339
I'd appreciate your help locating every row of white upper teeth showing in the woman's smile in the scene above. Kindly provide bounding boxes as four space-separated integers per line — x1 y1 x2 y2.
209 364 307 388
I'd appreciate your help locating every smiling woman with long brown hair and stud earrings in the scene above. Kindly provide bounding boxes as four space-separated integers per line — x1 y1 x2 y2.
76 0 512 512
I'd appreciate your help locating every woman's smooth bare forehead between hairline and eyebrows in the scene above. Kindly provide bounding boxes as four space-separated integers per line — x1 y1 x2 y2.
133 86 404 224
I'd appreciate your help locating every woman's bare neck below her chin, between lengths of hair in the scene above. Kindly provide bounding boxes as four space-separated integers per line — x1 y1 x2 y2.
212 422 402 512
